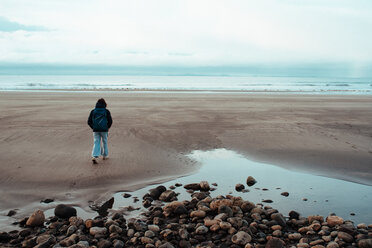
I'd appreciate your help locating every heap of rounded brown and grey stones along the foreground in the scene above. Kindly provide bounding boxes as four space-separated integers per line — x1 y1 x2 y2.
0 178 372 248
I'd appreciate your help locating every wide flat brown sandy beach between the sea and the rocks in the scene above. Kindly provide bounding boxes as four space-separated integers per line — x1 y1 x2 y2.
0 91 372 211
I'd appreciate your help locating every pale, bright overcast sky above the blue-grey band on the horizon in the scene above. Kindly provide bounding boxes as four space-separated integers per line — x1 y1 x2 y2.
0 0 372 66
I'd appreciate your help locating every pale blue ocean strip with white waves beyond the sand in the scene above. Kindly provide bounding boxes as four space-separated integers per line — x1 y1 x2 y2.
0 75 372 95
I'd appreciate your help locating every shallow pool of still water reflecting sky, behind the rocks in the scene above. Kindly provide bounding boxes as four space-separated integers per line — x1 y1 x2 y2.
113 149 372 224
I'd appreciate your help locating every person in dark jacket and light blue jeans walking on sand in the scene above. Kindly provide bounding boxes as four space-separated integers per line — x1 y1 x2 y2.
88 98 112 164
